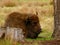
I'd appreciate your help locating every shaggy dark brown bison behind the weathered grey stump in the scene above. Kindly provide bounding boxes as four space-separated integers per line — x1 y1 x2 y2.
5 12 41 38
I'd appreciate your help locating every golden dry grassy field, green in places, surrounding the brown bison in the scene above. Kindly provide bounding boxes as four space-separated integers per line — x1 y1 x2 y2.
0 0 54 45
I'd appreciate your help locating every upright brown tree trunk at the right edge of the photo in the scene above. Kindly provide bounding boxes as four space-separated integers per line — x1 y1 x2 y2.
52 0 60 39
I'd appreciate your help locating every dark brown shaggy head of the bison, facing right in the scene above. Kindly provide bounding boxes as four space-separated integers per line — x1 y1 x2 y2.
25 15 41 38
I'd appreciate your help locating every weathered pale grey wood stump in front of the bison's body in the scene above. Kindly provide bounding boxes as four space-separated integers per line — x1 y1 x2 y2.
5 27 24 42
